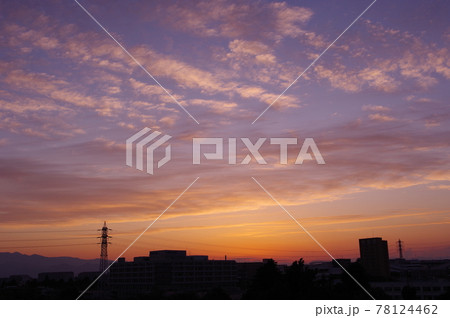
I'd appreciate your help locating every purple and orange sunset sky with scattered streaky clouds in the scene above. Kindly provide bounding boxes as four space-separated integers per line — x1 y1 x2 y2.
0 0 450 263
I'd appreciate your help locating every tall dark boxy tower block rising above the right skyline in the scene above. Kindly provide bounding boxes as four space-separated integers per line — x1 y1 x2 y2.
359 237 389 278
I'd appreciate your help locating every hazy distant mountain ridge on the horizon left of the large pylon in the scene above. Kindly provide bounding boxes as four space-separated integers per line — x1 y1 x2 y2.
0 252 99 277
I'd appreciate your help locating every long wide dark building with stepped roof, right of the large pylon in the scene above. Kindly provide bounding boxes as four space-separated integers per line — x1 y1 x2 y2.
109 250 238 294
